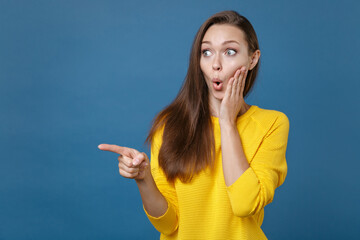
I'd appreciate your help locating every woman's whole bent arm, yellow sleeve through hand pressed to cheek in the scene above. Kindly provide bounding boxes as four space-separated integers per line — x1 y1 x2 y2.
219 67 289 217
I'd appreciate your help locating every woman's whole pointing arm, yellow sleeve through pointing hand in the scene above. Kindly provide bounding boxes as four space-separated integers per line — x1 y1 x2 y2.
99 142 178 235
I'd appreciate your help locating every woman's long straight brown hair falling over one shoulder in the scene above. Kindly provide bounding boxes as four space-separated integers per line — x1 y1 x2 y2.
146 11 259 182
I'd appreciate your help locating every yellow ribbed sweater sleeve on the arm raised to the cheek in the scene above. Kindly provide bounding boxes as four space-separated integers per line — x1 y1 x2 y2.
227 112 289 217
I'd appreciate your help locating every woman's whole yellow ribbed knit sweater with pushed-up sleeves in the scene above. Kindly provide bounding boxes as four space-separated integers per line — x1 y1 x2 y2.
144 105 289 240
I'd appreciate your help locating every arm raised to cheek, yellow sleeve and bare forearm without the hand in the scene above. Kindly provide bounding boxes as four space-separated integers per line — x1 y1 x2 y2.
221 114 289 217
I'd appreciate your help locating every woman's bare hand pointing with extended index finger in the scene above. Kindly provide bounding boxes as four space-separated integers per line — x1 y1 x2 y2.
98 144 151 180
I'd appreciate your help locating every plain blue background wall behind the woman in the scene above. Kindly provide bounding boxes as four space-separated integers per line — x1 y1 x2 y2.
0 0 360 239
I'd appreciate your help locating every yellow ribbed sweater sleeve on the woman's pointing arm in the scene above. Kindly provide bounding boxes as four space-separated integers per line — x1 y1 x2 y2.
144 126 178 235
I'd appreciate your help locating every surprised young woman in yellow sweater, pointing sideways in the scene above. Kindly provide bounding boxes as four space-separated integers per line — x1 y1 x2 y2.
99 11 289 240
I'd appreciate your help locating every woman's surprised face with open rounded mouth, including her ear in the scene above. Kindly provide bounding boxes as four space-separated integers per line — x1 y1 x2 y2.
200 24 258 101
